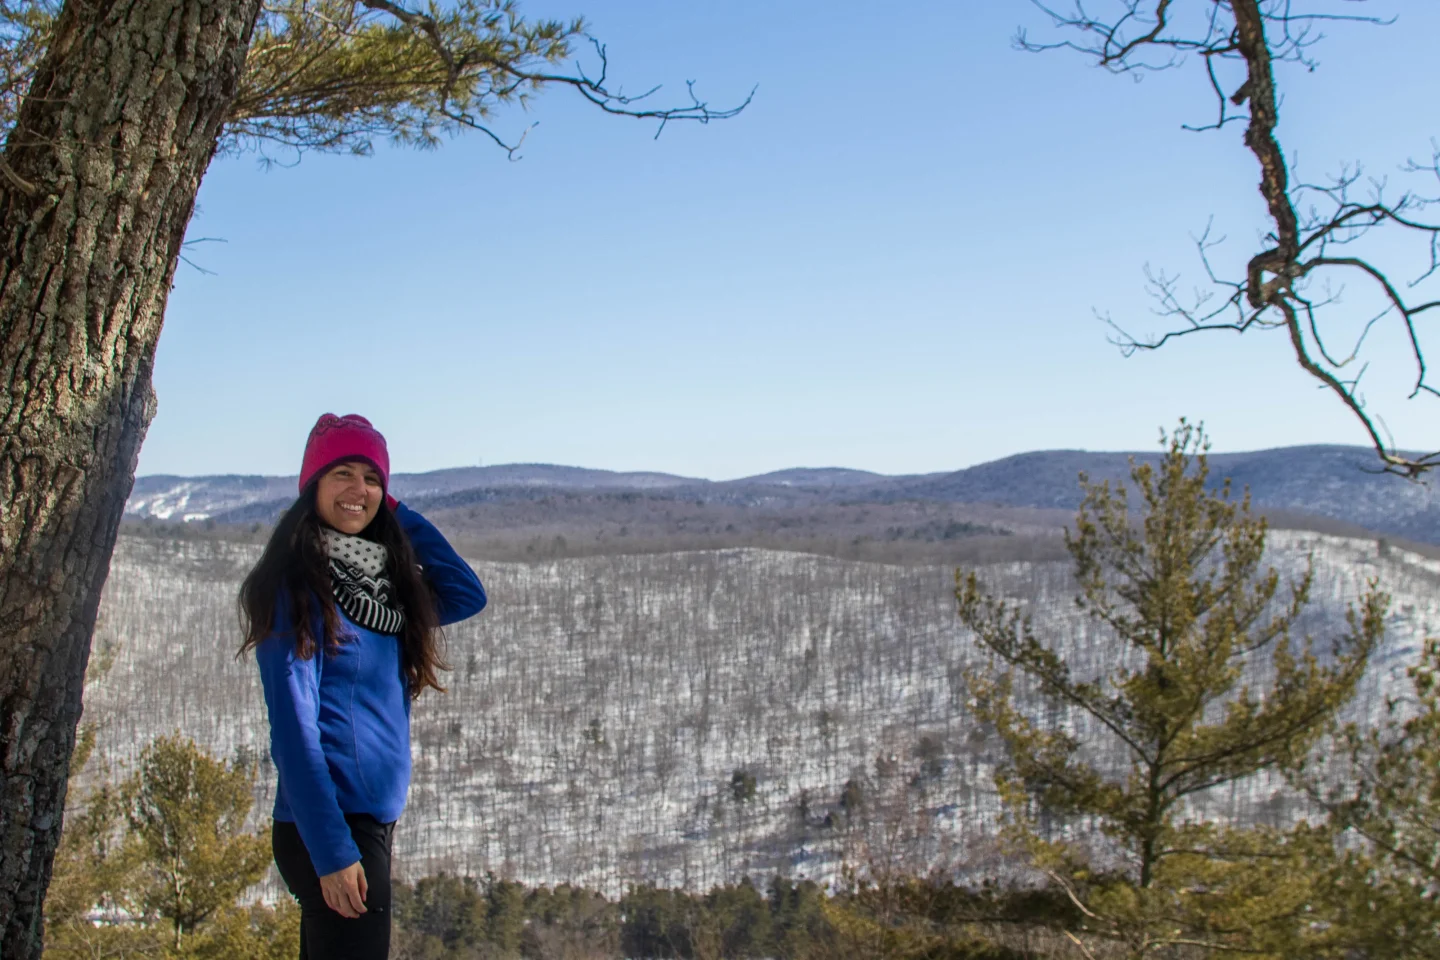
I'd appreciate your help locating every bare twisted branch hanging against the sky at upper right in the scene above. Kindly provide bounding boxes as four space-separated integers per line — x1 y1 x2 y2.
1017 0 1440 478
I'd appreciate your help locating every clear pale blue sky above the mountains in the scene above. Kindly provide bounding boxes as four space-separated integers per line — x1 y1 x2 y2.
140 0 1440 479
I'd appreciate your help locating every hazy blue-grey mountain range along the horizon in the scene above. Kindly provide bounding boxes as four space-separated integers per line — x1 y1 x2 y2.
125 446 1440 543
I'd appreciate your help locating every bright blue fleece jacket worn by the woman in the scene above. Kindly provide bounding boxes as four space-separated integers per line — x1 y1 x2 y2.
255 504 485 877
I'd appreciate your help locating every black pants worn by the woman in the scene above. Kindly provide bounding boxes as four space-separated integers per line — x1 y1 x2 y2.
271 813 395 960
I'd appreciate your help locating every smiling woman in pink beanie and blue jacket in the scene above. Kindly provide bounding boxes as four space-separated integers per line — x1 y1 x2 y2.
240 413 485 960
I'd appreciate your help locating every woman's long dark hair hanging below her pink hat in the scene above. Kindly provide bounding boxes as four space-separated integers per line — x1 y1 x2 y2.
238 484 449 697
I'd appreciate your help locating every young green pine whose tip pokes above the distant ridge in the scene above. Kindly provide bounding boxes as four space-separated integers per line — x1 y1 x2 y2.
956 420 1388 957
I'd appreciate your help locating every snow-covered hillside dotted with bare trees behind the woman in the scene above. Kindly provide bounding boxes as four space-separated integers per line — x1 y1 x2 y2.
85 534 1440 889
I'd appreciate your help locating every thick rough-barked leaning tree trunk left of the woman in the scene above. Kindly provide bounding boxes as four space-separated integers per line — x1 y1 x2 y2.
0 0 259 960
